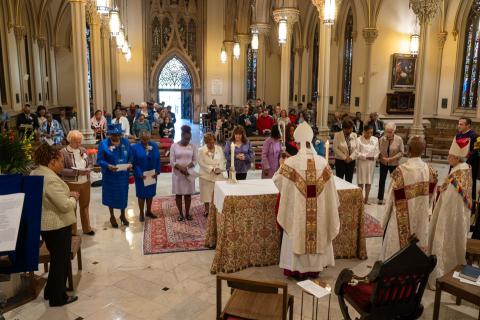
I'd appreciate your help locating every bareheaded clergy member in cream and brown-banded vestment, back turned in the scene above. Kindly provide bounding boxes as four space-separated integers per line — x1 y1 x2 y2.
380 136 437 260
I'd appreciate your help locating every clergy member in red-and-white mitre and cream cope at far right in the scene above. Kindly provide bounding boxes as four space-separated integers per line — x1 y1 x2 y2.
428 138 472 289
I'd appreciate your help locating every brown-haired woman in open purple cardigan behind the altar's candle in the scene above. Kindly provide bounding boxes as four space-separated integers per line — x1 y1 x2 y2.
224 126 253 180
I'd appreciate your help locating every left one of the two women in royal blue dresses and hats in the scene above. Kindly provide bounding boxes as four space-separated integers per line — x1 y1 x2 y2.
97 124 132 228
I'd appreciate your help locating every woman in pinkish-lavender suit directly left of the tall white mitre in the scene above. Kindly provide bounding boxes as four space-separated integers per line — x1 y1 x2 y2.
262 125 282 179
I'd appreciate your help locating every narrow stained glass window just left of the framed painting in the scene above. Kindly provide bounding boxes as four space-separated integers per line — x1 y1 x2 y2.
342 8 353 105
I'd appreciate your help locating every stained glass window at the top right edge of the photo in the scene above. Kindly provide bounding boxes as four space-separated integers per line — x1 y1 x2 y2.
459 0 480 109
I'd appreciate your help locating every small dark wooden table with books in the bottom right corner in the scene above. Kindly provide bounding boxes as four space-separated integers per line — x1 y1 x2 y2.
433 266 480 320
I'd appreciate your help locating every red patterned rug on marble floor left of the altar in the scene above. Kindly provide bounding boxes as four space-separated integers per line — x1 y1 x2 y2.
143 194 208 254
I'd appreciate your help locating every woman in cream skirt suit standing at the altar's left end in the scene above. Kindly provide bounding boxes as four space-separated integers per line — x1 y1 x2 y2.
198 132 226 217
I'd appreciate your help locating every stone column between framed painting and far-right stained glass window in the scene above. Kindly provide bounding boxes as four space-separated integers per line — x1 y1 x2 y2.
410 0 439 136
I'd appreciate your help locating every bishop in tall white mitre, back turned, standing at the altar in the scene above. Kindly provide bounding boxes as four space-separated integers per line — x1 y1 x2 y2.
273 122 340 278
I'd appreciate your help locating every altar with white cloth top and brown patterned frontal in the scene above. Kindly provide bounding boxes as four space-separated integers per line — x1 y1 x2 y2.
205 177 367 274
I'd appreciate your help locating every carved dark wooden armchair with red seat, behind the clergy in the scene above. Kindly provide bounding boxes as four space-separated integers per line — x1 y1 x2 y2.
335 237 437 320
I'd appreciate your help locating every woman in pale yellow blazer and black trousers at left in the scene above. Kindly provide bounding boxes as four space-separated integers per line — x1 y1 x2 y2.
30 144 79 307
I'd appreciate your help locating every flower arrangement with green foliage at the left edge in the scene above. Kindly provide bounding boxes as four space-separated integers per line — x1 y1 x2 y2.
0 130 34 174
